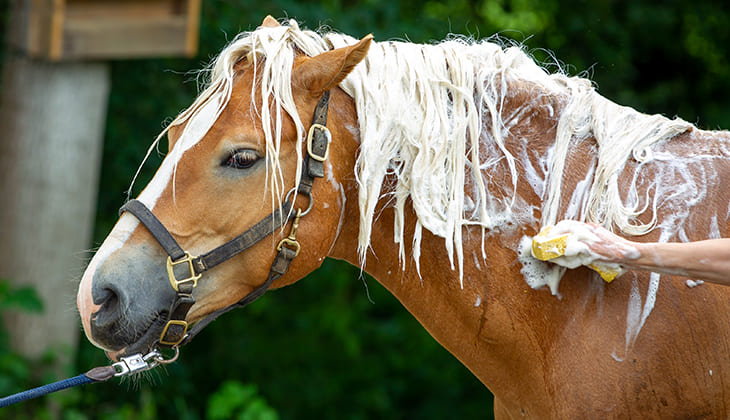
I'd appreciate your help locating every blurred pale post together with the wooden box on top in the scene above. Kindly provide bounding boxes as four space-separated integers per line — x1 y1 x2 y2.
0 0 200 368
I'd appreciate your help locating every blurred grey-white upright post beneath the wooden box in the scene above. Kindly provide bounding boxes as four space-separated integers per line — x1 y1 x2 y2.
0 2 109 366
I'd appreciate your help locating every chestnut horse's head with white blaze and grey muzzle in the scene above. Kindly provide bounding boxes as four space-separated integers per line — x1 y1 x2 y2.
78 18 372 358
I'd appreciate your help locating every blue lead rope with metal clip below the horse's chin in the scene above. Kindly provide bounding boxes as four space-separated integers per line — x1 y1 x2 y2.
0 348 180 408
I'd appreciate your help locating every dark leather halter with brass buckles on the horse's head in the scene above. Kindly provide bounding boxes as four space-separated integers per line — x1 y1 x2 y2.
119 91 331 348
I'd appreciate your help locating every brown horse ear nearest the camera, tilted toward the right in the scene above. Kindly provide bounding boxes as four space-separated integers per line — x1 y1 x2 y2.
292 34 373 95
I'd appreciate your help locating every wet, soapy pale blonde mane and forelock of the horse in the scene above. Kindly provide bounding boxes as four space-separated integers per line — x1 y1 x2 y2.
162 20 691 286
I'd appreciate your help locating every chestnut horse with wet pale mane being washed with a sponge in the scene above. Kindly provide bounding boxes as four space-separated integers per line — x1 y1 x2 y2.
78 17 730 418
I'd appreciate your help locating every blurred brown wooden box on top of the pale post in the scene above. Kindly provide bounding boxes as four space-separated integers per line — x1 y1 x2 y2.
13 0 201 61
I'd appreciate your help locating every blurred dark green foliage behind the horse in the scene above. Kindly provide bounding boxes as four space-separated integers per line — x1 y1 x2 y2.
0 0 730 419
